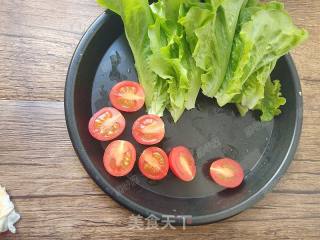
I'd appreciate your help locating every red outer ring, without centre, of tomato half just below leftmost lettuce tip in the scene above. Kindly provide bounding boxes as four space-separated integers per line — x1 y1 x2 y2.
132 114 165 145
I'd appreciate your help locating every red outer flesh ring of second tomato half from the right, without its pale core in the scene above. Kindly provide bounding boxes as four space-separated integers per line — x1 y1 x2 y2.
169 146 196 182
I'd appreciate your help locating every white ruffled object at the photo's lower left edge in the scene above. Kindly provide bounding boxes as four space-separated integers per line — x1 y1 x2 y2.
0 185 20 233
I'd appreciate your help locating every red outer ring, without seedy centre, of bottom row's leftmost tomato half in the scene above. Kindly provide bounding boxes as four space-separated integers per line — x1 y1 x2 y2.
103 140 137 177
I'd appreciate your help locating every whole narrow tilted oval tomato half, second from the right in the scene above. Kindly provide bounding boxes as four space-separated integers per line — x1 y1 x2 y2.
169 146 196 182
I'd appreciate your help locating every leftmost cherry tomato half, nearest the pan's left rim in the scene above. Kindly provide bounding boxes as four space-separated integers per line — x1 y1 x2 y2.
89 107 126 141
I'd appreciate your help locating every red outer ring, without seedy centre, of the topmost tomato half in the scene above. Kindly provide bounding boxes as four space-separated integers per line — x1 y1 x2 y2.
109 80 145 112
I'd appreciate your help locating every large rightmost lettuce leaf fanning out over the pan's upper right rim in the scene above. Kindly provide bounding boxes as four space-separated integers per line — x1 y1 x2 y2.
216 1 307 106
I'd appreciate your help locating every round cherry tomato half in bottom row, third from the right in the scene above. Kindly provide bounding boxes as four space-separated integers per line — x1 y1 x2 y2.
139 147 169 180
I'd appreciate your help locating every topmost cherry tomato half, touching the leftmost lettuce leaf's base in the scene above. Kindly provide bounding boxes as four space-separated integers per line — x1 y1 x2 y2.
109 81 145 112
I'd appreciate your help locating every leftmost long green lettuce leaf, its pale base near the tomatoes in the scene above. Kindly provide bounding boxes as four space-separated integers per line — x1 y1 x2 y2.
97 0 168 116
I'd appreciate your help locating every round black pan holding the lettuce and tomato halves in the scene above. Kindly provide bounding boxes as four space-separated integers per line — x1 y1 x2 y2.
65 12 302 225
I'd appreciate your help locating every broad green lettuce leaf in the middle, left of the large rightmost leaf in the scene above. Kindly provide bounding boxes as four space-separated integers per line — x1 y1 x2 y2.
180 0 246 97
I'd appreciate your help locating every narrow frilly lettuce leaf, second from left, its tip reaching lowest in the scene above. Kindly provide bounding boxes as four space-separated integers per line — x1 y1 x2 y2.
148 1 189 121
